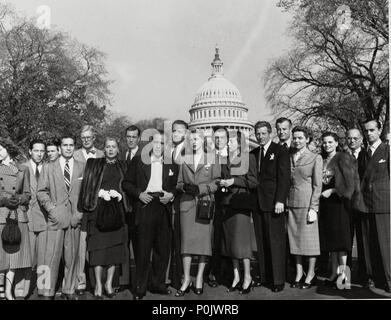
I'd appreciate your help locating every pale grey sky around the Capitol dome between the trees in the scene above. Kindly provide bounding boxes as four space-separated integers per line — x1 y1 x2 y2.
9 0 291 121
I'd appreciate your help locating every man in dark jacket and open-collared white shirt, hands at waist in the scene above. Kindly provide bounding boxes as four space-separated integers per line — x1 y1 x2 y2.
122 132 178 300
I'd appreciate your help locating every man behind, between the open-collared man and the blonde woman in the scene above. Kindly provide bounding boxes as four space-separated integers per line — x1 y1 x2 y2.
168 120 188 290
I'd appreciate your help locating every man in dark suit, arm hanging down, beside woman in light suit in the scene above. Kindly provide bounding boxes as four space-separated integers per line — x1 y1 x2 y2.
251 121 290 292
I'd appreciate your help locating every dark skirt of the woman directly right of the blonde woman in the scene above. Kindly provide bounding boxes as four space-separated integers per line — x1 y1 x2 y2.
221 213 253 259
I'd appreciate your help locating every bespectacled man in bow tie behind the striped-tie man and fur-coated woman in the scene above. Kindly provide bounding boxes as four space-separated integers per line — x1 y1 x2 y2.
73 125 105 296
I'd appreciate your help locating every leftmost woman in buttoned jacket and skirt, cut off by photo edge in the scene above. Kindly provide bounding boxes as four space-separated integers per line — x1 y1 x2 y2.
0 139 32 300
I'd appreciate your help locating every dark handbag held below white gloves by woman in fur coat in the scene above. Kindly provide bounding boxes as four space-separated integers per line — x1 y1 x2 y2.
95 199 123 232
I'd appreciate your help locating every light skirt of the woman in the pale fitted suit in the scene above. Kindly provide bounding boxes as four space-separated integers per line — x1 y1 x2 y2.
288 208 320 256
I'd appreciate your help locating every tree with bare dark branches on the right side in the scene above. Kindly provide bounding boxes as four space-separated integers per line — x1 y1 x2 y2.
265 0 389 134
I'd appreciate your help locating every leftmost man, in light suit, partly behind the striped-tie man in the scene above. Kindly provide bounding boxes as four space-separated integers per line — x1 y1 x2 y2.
23 139 48 296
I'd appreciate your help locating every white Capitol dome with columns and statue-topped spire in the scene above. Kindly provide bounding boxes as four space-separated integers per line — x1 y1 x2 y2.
189 47 253 136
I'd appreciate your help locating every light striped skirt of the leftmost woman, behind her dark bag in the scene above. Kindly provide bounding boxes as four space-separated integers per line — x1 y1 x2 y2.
0 222 32 271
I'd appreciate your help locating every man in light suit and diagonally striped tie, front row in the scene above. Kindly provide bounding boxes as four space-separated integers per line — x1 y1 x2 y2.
37 136 85 300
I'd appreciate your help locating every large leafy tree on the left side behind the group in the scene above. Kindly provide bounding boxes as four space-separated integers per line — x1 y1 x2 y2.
0 5 110 154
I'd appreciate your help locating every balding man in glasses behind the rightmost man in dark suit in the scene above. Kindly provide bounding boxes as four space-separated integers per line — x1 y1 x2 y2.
346 128 369 282
